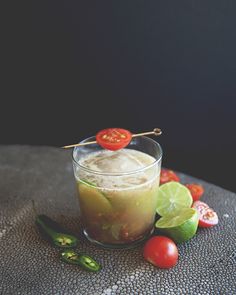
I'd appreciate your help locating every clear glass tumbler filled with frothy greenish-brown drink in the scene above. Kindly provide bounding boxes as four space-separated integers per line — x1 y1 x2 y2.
73 136 162 248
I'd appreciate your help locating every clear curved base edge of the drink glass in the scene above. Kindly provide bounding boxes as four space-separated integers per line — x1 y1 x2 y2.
83 228 154 249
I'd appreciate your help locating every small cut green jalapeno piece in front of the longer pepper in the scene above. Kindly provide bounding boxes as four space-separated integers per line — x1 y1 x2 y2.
60 249 101 272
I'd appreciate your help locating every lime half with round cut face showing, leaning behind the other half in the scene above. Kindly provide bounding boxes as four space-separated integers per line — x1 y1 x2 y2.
156 181 193 216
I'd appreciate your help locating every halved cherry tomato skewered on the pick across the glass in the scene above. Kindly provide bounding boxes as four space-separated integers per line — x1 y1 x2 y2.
96 128 132 151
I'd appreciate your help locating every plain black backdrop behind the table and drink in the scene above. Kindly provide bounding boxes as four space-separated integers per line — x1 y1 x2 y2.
0 0 236 191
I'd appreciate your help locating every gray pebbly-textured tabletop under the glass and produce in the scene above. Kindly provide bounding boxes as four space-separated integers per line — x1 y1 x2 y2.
0 146 236 295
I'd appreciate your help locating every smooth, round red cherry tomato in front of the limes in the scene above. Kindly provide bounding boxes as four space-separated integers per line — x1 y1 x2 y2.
143 236 178 268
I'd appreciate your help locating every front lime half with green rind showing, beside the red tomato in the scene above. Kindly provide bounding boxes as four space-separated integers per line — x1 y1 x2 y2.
155 208 198 243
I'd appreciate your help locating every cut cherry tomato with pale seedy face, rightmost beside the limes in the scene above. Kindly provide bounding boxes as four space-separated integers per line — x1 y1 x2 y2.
192 201 218 227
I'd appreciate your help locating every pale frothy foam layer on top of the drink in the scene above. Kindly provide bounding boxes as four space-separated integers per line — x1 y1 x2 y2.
76 149 159 190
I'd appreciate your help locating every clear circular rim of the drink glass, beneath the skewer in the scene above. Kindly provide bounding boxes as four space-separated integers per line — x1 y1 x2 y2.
72 136 163 176
